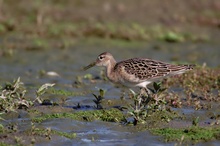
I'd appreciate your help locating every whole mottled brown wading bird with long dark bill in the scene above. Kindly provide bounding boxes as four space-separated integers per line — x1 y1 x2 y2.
84 52 194 88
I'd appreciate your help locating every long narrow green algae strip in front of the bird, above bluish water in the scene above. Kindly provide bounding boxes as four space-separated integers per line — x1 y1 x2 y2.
32 108 124 123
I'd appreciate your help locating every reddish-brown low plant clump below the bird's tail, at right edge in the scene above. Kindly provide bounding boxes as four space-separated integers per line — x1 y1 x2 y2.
163 64 220 110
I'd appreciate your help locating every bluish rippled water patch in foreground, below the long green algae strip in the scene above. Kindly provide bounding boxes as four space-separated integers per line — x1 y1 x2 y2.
38 119 172 145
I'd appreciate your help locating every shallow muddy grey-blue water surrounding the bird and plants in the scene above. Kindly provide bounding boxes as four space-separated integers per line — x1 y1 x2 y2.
0 42 220 146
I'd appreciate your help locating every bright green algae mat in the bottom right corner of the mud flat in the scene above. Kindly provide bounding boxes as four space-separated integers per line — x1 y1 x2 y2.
151 126 220 142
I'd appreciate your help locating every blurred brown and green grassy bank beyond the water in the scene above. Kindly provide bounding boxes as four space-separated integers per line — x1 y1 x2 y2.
0 0 220 41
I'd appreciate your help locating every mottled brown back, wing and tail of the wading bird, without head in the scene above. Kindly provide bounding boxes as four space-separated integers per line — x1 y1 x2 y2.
114 58 194 83
